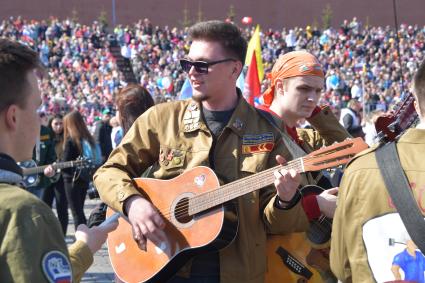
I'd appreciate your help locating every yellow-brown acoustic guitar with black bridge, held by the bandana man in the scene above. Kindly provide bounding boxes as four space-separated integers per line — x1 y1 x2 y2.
265 185 337 283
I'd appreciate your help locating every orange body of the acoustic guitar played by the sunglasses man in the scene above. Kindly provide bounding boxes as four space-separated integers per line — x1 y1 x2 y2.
107 167 238 282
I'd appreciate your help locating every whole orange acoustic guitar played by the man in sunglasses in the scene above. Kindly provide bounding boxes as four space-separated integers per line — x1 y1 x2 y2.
107 138 367 282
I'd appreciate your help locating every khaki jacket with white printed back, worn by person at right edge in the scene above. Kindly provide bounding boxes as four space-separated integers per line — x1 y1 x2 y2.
330 129 425 283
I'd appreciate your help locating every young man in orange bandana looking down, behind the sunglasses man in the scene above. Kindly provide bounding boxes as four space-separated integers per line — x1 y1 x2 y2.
261 51 350 282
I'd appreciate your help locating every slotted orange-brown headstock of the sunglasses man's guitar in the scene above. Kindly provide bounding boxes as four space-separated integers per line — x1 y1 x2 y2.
303 138 368 172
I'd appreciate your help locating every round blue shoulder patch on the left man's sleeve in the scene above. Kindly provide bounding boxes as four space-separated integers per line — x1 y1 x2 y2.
41 251 72 283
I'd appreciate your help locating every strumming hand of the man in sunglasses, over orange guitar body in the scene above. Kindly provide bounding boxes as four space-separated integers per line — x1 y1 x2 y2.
125 195 166 251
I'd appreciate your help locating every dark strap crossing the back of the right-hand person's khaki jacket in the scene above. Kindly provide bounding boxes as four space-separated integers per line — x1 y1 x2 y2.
376 142 425 253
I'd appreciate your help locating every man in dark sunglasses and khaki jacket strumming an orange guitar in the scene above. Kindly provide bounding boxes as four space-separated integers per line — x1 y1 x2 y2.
94 21 308 283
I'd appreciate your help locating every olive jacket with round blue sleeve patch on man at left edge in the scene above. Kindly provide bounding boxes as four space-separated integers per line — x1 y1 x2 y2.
0 183 93 283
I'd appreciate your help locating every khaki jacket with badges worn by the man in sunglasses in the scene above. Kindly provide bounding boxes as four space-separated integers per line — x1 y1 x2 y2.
94 98 308 283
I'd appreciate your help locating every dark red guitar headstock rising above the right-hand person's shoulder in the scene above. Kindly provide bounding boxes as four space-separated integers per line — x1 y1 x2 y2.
375 93 419 142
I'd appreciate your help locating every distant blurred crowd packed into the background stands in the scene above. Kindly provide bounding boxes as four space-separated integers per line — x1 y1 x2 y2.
0 17 425 129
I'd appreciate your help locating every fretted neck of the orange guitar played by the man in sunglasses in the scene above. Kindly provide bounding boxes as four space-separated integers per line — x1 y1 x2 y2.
189 158 305 215
